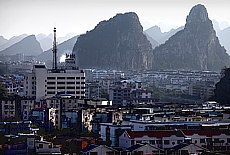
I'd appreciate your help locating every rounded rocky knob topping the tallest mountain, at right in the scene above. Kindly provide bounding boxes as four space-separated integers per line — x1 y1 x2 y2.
186 4 209 24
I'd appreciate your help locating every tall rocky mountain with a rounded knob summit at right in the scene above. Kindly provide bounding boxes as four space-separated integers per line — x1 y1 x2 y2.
154 4 230 70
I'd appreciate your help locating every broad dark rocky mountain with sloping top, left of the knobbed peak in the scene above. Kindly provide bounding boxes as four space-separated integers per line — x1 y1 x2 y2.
73 12 153 70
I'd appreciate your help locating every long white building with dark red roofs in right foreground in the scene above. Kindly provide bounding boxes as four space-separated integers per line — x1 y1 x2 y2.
119 130 230 151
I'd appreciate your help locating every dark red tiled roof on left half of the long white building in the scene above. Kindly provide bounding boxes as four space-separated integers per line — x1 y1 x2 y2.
127 130 184 139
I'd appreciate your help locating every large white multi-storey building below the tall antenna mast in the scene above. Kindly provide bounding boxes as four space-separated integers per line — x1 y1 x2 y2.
24 65 85 101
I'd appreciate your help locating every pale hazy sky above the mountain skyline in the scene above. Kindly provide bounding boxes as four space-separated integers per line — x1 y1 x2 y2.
0 0 230 39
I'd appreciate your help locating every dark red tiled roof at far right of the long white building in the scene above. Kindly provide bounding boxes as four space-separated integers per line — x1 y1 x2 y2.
182 130 225 137
